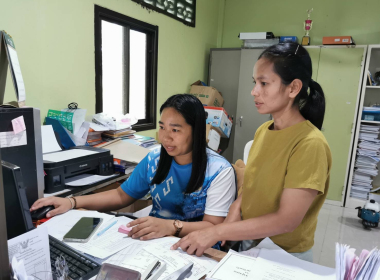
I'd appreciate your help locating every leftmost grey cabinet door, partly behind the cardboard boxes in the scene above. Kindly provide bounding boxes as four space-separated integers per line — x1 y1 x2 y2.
208 49 241 162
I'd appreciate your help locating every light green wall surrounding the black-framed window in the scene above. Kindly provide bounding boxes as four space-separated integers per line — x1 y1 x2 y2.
0 0 224 136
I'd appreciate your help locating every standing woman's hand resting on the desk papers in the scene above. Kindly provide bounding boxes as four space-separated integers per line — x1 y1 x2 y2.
170 227 219 257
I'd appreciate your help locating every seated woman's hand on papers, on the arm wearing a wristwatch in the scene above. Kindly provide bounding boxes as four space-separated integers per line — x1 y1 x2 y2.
127 217 175 240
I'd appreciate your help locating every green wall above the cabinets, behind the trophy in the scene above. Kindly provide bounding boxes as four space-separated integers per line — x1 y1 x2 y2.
222 0 380 48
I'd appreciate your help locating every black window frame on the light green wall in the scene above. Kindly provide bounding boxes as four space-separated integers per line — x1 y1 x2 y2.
94 5 158 131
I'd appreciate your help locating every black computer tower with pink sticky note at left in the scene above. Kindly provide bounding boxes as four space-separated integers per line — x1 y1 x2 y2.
0 107 44 206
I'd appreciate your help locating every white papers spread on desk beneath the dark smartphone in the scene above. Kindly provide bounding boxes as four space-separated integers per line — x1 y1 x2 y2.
39 210 217 280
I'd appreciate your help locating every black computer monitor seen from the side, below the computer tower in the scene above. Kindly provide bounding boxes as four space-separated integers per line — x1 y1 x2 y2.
1 161 34 239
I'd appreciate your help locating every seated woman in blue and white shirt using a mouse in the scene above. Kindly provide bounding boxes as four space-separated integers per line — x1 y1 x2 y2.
31 94 236 240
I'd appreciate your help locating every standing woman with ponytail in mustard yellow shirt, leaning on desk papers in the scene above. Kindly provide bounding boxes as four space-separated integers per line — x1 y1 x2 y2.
172 43 331 261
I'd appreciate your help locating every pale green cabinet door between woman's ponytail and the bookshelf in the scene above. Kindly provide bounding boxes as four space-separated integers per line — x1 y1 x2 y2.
316 48 363 201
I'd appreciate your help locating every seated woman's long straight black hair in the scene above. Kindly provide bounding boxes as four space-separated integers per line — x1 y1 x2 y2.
151 94 207 193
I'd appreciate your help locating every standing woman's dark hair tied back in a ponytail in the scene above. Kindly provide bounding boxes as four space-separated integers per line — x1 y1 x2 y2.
259 43 326 130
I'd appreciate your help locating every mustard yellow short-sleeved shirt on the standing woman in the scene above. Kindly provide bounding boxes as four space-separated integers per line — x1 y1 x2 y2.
241 121 332 253
